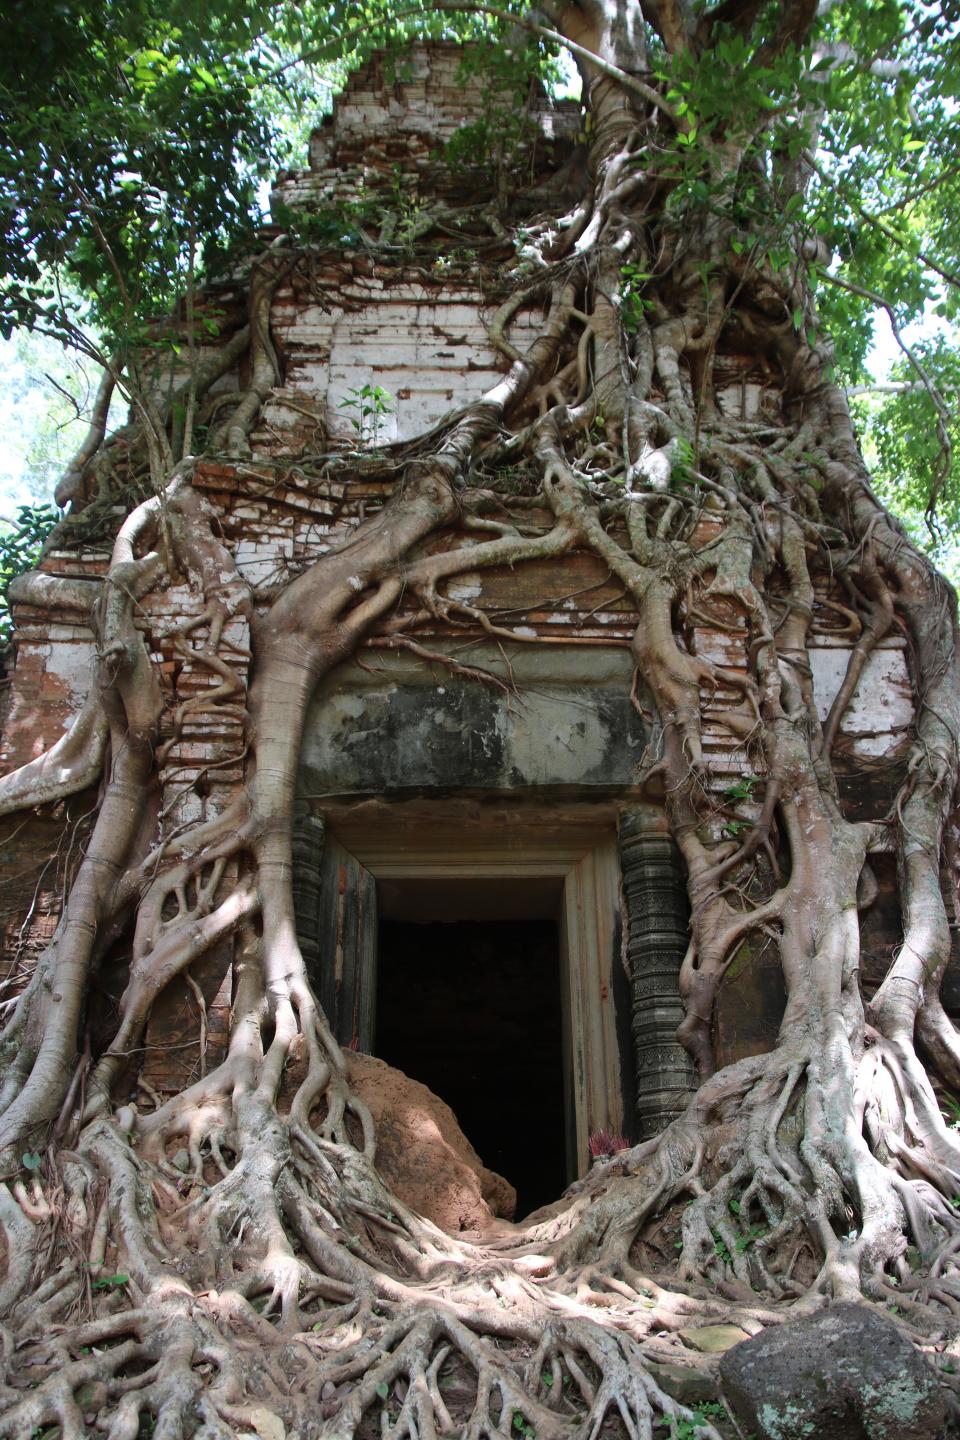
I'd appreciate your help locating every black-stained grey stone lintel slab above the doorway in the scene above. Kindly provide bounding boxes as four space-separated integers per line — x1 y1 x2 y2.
301 644 646 798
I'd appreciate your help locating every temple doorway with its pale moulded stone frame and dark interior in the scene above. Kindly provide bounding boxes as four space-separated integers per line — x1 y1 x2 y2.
303 805 632 1186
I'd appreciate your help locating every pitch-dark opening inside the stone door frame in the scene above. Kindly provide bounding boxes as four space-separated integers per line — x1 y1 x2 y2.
376 881 567 1218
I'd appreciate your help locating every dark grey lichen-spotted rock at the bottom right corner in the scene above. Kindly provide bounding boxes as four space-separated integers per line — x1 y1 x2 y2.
720 1303 947 1440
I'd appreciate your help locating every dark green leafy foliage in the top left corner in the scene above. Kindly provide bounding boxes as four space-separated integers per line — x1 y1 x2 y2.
0 0 275 346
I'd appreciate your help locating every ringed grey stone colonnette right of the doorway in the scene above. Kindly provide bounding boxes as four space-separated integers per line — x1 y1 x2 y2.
620 811 695 1139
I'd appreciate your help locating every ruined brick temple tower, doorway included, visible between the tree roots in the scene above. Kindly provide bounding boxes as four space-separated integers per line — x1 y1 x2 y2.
0 43 932 1208
